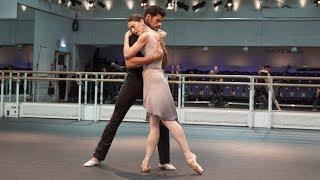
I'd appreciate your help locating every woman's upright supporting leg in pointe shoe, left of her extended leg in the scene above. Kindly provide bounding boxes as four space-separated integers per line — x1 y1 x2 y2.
141 116 160 170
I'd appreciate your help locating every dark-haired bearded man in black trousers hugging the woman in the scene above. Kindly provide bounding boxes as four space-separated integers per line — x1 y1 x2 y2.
84 6 176 170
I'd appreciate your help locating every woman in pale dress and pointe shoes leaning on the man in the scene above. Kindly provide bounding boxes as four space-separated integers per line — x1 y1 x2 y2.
123 14 203 174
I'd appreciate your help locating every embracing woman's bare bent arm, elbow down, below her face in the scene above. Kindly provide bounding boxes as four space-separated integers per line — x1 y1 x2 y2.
123 31 148 59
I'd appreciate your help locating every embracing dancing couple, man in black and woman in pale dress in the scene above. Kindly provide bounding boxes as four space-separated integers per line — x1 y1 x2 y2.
84 6 203 174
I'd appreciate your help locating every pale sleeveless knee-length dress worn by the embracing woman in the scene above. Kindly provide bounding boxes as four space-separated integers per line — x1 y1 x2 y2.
142 30 178 121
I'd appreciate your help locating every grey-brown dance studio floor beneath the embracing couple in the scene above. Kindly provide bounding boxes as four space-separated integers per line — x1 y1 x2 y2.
0 118 320 180
